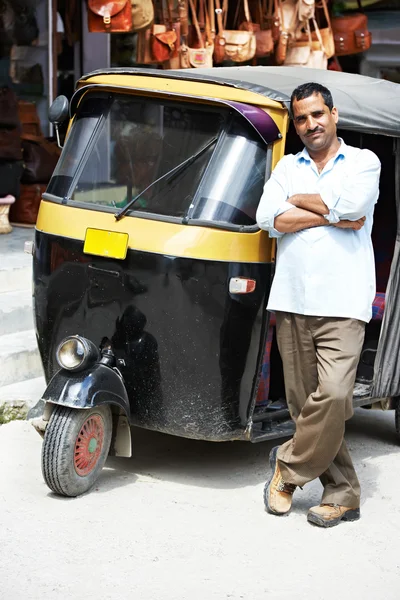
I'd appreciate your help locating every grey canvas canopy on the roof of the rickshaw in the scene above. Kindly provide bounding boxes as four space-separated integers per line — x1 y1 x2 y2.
81 67 400 137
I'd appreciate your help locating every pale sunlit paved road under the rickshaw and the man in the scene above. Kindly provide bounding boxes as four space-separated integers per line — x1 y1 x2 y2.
0 410 400 600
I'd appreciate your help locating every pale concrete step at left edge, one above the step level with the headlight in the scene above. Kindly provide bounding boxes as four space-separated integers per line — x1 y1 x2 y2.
0 290 33 336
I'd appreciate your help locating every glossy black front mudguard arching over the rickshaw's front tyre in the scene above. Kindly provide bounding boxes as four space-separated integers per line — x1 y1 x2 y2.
27 363 132 457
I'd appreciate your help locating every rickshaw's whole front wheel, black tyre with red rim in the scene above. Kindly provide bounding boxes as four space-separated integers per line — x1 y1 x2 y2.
42 405 112 496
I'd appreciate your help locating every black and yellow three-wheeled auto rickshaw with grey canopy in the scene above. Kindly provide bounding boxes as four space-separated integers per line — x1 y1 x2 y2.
30 67 400 496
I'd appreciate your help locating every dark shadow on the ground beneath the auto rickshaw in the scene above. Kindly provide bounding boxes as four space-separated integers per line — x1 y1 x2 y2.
96 409 399 500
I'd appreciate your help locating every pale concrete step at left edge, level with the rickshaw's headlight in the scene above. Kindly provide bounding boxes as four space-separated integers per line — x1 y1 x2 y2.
0 330 43 387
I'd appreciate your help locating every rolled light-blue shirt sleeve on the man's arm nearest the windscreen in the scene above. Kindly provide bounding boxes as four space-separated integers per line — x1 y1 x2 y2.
256 156 294 238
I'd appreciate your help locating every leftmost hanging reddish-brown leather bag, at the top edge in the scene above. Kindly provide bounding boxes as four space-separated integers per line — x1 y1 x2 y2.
88 0 132 33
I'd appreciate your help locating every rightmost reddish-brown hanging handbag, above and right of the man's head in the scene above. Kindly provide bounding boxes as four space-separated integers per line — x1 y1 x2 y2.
332 0 372 56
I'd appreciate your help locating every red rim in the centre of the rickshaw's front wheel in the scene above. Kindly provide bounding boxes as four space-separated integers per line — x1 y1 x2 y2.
74 415 104 477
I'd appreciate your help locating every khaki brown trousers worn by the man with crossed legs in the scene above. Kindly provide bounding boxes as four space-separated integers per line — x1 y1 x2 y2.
276 312 365 508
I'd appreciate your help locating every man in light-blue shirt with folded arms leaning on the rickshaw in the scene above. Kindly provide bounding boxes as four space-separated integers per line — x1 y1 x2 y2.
257 83 380 527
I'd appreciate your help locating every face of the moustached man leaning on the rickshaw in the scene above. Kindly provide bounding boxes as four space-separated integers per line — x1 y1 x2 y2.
293 94 338 152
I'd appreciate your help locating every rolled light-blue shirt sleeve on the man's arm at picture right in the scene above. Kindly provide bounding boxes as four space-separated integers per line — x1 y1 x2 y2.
319 149 381 223
